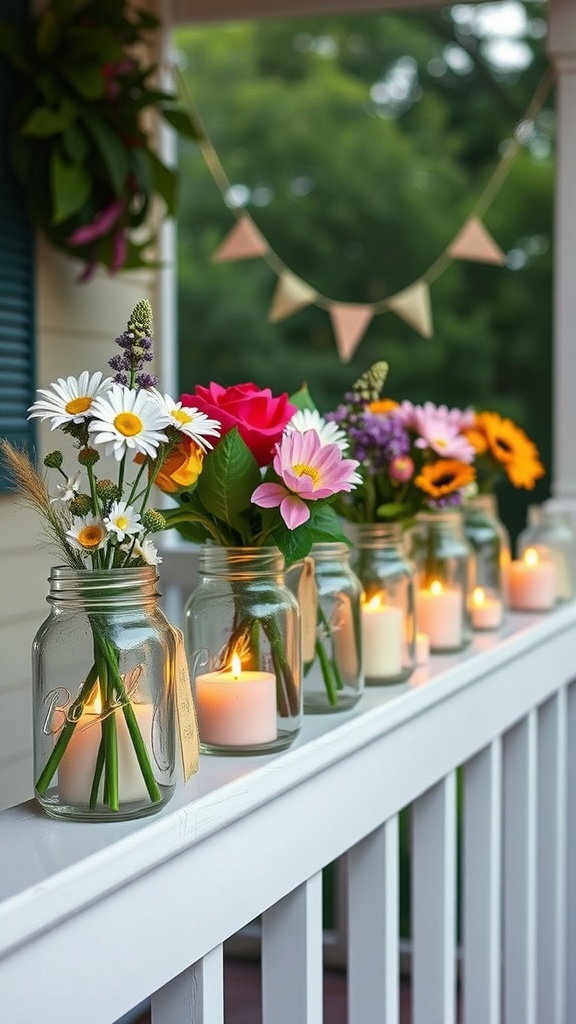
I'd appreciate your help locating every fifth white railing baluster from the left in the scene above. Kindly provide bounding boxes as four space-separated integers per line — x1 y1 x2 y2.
462 737 502 1024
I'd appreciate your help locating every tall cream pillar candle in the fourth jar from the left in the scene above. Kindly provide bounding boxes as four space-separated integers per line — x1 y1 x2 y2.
362 594 404 679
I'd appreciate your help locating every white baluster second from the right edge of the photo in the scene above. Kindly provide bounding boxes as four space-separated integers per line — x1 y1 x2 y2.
537 689 567 1024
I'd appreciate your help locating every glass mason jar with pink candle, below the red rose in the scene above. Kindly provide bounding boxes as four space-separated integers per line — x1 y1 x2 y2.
184 544 302 755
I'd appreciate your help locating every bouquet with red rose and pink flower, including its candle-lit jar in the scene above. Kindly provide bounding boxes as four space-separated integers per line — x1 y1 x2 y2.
156 382 360 753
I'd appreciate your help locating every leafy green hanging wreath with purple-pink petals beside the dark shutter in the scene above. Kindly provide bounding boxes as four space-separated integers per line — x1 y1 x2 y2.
0 0 198 281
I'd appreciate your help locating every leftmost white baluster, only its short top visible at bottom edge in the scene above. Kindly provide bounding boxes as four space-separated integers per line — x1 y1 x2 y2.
152 945 224 1024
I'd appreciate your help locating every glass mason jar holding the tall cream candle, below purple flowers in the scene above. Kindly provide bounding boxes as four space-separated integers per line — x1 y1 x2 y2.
346 522 416 686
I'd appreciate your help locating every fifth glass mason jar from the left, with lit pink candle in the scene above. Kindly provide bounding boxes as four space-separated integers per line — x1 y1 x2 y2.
406 509 475 652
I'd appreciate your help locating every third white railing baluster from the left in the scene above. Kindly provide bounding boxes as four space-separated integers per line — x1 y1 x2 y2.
347 815 400 1024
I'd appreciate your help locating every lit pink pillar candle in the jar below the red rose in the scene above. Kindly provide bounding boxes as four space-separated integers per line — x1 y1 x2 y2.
195 654 278 746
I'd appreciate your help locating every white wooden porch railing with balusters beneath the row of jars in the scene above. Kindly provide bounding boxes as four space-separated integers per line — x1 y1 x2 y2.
0 577 576 1024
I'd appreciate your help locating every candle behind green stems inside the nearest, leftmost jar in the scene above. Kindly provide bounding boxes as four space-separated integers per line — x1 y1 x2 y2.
58 702 154 804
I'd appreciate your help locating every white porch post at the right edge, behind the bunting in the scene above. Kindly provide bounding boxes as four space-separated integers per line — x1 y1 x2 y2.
547 0 576 507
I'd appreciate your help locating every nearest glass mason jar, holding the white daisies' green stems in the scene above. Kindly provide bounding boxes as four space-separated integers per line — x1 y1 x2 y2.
32 565 176 821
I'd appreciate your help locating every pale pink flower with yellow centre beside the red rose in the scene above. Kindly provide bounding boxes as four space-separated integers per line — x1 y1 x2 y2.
252 430 361 529
